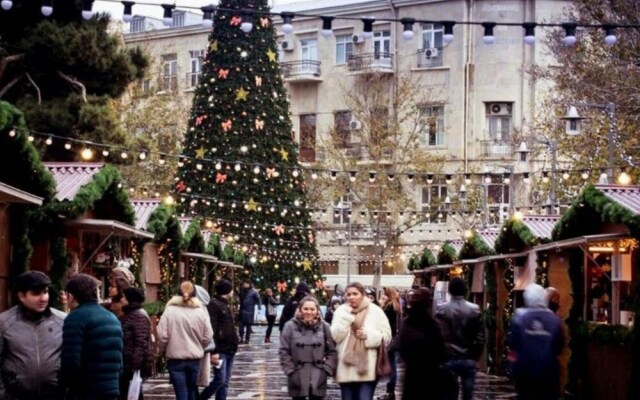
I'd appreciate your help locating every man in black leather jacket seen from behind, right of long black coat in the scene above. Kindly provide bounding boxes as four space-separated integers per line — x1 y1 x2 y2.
437 278 484 400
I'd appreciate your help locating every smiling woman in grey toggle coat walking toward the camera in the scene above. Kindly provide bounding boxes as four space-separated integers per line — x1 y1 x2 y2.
280 296 338 400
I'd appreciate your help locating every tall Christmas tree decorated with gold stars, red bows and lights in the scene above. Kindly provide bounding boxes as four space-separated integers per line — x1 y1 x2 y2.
175 0 324 296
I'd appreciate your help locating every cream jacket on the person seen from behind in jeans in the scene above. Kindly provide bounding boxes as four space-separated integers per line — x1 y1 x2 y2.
158 296 213 360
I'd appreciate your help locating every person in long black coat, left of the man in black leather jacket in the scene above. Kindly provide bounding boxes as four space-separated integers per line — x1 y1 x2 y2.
398 288 453 400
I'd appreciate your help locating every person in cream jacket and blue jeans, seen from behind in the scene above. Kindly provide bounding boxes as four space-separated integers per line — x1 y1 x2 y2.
158 282 213 400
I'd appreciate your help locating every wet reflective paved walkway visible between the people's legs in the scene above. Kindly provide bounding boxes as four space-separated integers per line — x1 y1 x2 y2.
143 326 515 400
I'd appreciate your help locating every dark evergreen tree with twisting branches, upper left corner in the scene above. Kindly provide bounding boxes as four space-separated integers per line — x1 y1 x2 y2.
0 0 148 160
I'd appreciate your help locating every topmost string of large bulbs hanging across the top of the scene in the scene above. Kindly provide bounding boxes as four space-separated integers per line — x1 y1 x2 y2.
6 0 640 46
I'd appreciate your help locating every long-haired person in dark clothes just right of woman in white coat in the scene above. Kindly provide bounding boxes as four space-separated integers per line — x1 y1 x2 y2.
378 287 402 400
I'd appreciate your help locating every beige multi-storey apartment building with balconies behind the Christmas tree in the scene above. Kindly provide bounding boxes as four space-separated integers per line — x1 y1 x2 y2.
124 0 570 286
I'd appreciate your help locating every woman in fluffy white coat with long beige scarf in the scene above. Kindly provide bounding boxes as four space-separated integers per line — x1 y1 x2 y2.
331 282 391 400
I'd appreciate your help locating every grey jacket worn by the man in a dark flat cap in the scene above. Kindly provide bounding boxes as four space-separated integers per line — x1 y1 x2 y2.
0 305 67 399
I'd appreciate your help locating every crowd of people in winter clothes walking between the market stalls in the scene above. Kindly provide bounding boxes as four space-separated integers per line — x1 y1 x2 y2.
0 268 566 400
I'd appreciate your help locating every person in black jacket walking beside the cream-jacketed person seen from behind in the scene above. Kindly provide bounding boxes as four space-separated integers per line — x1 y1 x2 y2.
200 279 240 400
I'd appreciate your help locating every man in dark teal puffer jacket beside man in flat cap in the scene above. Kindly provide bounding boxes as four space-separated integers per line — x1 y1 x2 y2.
61 274 122 400
